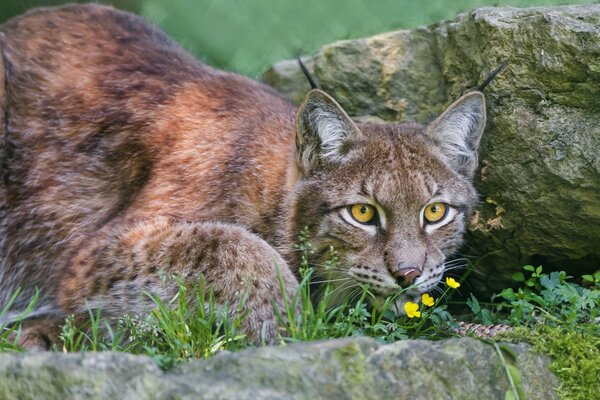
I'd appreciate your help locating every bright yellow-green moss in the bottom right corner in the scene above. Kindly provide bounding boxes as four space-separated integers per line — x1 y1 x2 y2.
503 325 600 400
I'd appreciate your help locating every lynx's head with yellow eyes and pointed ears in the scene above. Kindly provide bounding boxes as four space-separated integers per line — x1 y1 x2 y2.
292 90 486 310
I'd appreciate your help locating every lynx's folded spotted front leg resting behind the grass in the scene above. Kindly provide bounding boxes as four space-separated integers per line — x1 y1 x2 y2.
59 218 298 342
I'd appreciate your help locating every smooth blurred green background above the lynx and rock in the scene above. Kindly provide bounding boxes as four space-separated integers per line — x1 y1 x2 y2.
0 0 600 77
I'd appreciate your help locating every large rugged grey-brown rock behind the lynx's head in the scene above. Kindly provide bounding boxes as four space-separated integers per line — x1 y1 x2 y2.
265 5 600 293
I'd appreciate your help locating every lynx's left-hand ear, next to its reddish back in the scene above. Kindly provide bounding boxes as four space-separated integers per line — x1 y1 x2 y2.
296 90 360 174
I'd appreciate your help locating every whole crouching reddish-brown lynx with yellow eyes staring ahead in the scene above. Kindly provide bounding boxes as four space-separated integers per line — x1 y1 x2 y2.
0 5 486 348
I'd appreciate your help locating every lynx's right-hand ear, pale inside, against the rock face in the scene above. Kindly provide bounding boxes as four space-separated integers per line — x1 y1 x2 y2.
427 92 486 178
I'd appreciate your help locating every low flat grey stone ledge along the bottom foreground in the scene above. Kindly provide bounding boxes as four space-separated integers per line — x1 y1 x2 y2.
0 338 558 400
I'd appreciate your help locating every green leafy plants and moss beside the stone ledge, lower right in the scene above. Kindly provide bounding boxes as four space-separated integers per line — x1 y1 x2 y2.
482 265 600 399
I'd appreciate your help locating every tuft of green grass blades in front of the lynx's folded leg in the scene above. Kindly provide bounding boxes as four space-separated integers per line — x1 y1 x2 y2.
55 276 250 368
